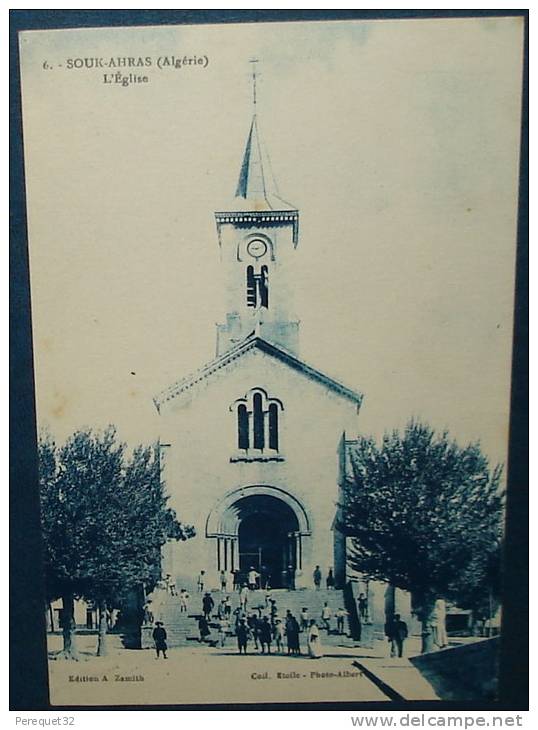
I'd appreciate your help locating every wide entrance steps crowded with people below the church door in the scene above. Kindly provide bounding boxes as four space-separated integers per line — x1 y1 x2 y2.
142 589 364 648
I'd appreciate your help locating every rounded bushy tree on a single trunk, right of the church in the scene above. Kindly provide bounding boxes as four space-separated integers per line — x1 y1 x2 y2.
340 421 502 652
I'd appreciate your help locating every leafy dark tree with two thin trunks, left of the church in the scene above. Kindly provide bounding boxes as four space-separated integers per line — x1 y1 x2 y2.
39 427 194 658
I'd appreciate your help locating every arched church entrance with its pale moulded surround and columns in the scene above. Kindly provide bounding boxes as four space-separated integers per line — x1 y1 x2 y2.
206 485 311 588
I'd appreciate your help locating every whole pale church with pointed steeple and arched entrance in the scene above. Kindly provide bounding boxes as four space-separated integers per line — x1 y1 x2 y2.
154 79 362 588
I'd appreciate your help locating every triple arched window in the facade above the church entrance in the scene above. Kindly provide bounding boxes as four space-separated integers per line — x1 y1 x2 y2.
232 388 284 451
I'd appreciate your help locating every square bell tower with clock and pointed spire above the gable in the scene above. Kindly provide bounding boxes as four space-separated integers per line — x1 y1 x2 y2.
215 59 299 355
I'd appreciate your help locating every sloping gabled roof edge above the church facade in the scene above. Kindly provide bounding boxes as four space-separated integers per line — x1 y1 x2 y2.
153 334 362 411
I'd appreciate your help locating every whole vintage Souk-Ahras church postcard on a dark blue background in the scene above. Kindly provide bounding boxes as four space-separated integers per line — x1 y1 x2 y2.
19 17 524 707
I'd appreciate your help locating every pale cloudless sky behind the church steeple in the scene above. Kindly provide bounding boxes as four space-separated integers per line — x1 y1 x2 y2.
21 18 523 470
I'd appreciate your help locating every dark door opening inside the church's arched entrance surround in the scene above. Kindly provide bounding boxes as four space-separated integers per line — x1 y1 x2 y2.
235 495 299 588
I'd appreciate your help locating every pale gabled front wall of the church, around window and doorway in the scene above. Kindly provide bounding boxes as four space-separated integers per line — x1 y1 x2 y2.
157 348 357 590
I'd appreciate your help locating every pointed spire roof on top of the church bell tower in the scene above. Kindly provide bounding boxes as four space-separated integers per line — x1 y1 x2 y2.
222 113 297 211
